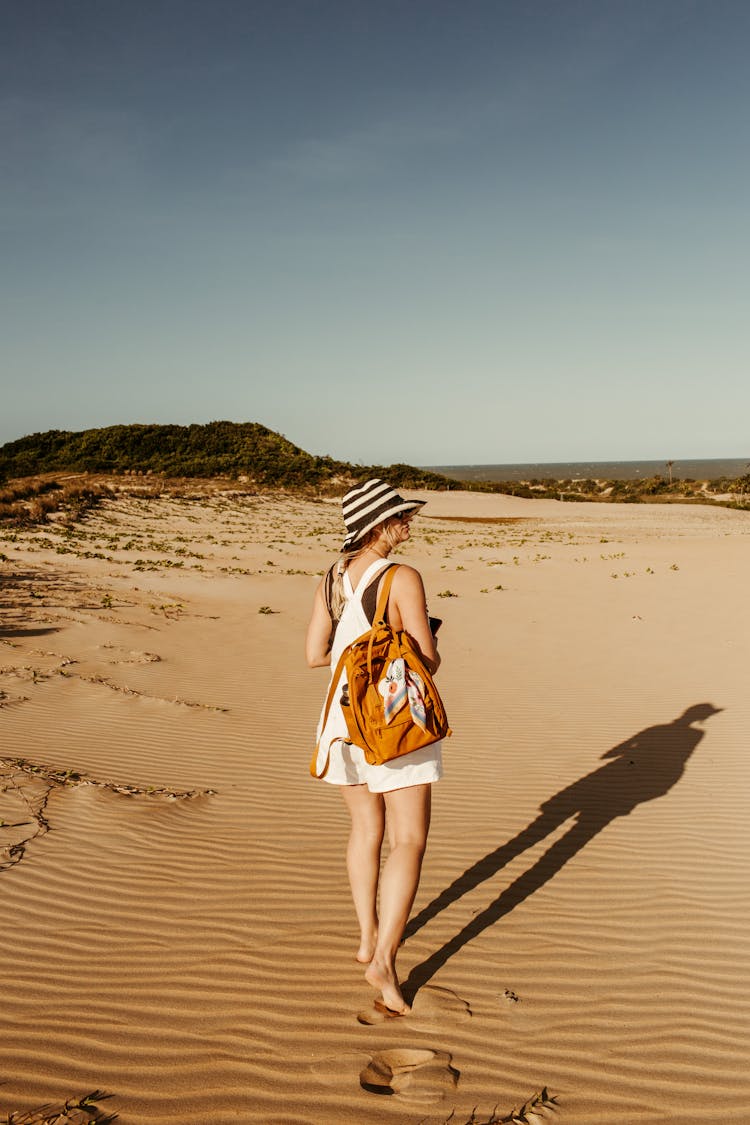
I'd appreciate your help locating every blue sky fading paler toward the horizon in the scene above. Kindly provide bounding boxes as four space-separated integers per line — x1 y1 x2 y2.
0 0 750 465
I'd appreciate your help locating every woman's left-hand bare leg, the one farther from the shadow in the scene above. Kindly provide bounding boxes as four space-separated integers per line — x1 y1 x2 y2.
342 785 386 965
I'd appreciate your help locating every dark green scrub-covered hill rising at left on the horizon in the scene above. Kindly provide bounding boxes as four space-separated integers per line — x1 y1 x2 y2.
0 422 460 488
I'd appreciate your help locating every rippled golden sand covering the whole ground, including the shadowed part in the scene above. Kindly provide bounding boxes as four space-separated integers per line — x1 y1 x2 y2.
0 493 750 1125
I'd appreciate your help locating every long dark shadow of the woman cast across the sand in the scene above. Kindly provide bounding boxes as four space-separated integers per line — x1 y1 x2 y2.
403 703 722 1004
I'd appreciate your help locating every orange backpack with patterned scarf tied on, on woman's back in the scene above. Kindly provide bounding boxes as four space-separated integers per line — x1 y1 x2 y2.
310 566 451 777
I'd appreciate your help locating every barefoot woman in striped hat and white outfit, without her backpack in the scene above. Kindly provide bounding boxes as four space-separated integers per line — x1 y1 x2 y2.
306 478 442 1016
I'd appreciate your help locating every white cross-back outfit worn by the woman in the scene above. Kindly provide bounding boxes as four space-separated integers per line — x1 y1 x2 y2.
317 559 443 793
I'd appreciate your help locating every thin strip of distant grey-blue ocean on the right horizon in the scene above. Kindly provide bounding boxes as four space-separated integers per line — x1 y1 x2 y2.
423 457 750 480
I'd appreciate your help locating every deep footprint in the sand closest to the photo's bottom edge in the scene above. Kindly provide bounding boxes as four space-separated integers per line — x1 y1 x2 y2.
360 1047 459 1103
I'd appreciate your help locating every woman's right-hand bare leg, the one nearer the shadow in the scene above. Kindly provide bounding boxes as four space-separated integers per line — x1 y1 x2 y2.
364 785 432 1013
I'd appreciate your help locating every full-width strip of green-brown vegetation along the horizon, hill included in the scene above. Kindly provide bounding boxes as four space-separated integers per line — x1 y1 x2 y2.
0 422 750 523
